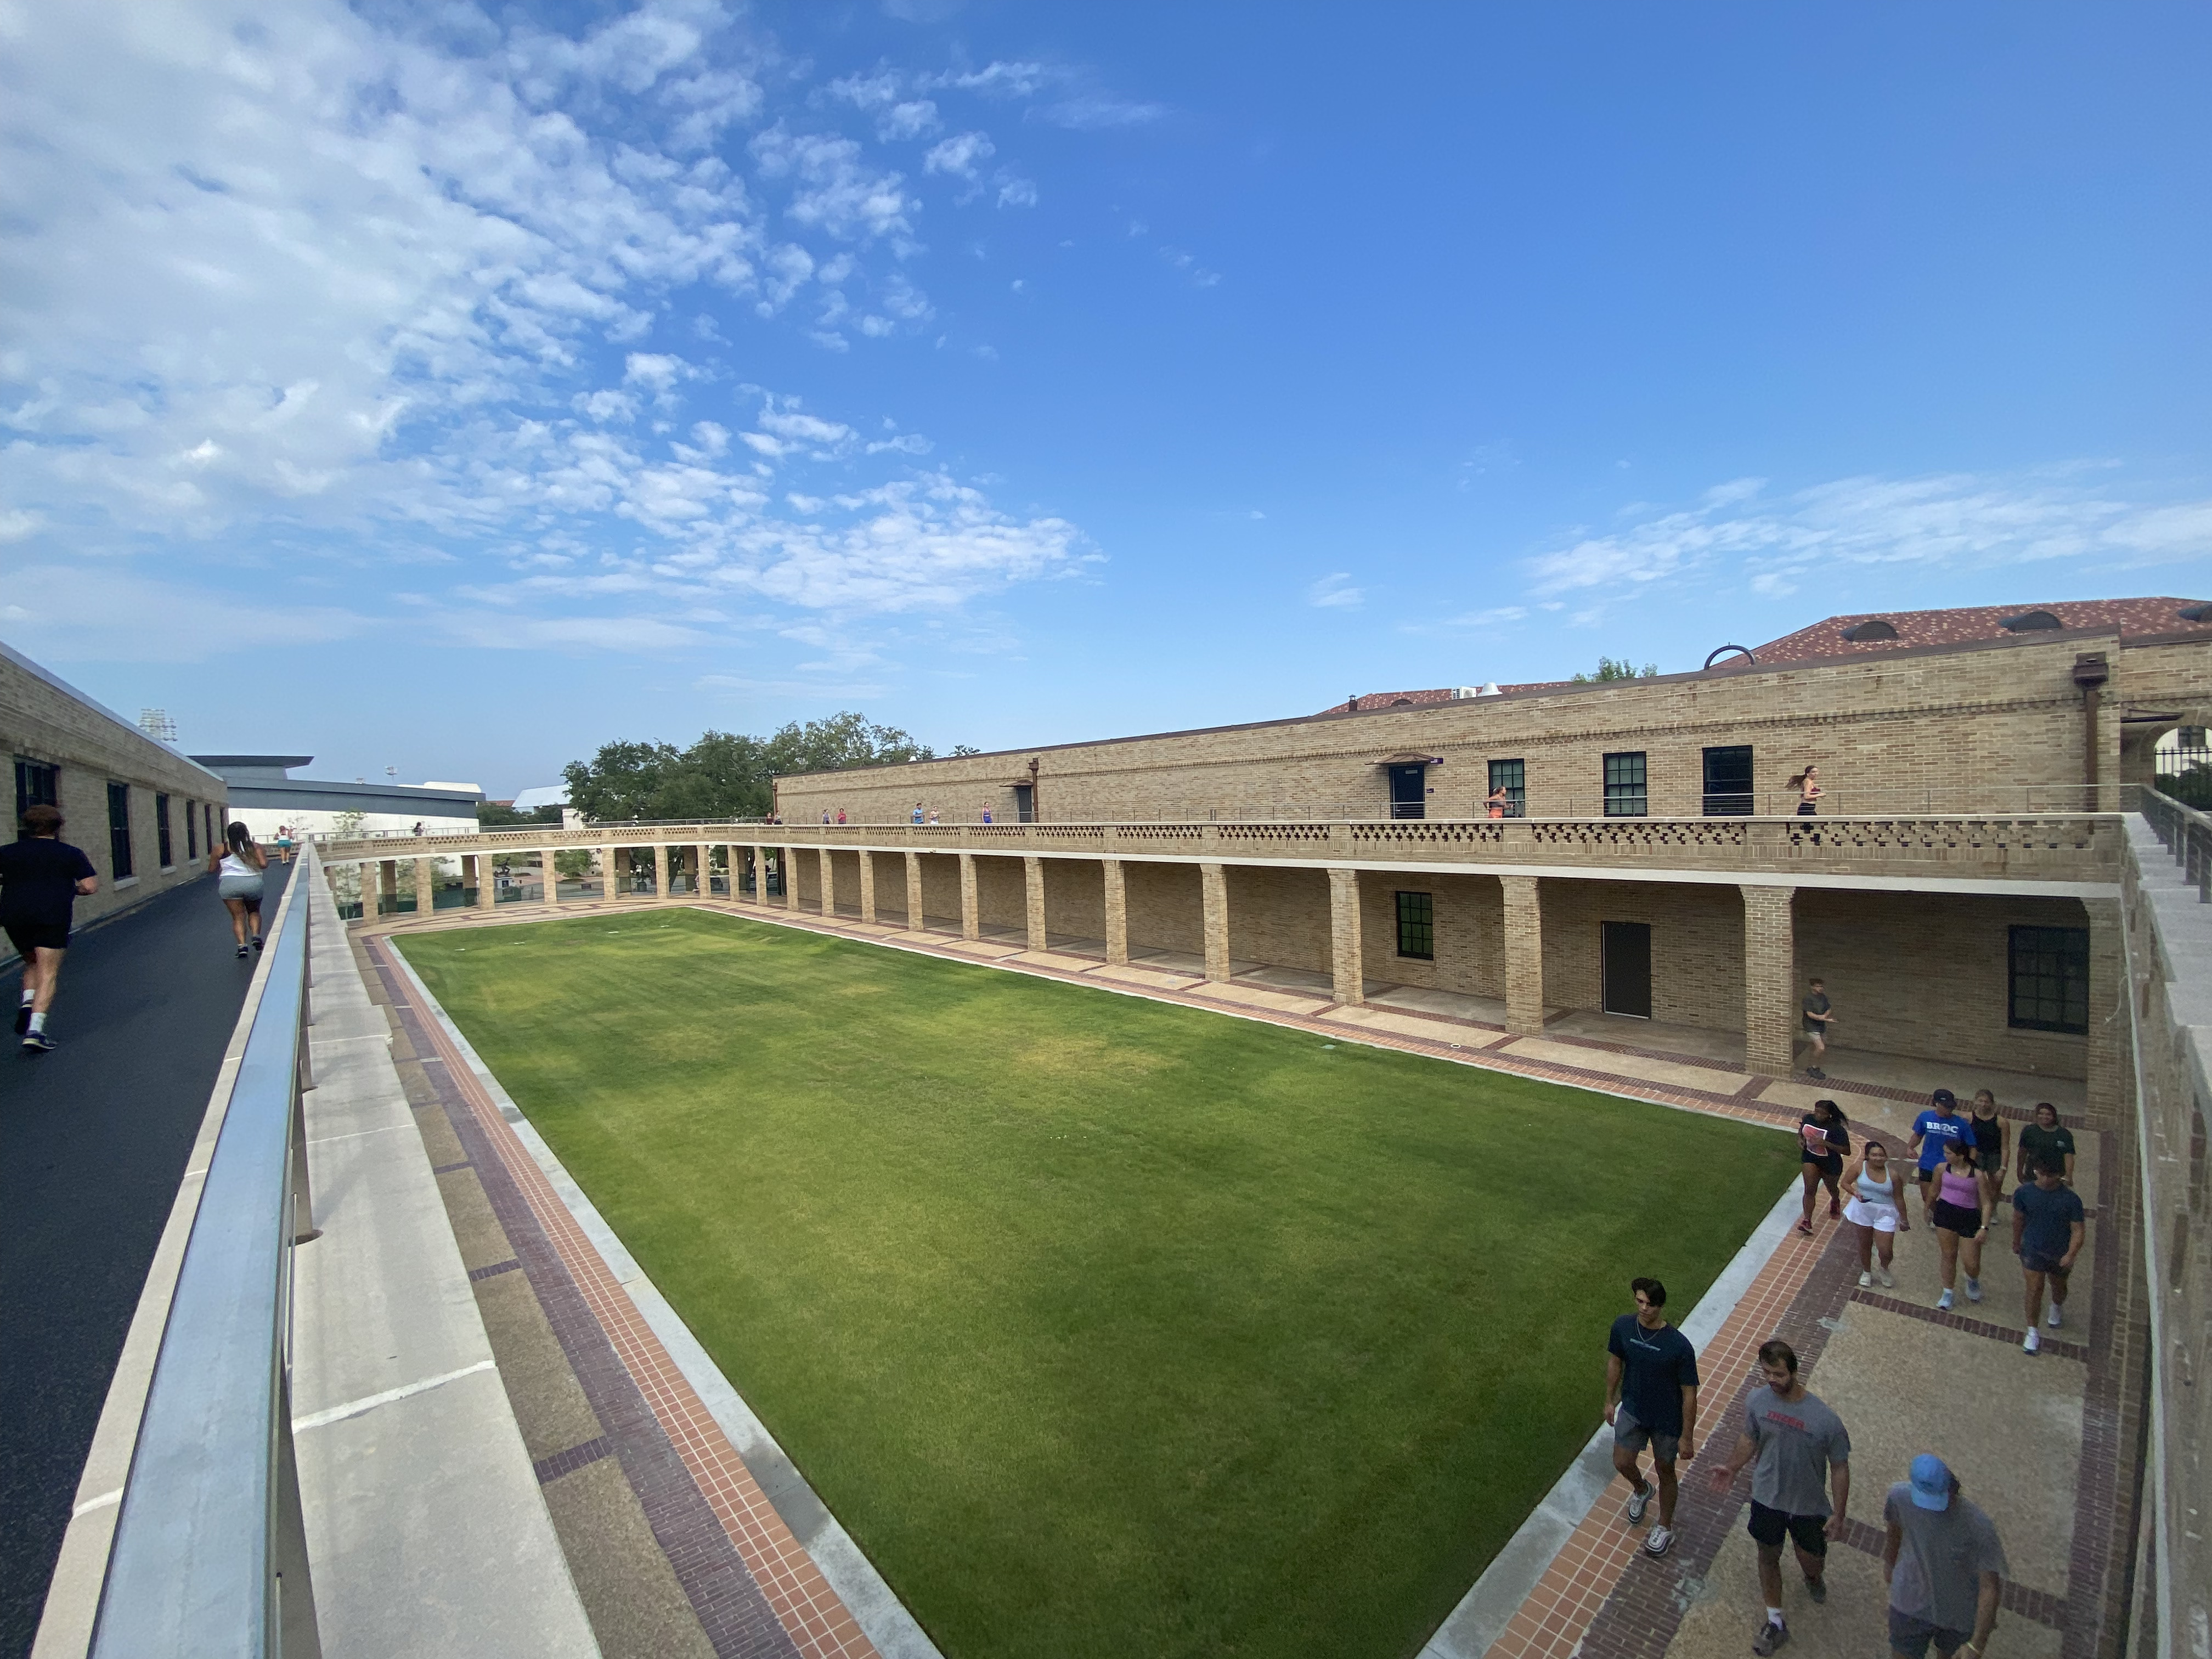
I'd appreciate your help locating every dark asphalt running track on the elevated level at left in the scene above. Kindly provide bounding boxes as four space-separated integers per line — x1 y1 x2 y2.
0 865 290 1659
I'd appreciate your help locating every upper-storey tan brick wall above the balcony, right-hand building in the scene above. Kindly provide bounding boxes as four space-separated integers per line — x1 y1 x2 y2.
778 635 2212 823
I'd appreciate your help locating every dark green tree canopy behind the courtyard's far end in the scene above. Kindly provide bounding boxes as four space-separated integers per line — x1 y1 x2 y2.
562 712 975 823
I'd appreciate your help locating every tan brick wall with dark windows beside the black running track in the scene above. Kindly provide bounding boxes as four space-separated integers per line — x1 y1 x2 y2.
0 652 225 927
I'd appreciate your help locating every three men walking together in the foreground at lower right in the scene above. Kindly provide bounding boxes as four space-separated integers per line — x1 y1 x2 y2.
1606 1278 2006 1659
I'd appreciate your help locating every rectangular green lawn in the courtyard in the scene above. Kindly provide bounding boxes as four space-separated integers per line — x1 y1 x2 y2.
403 911 1796 1659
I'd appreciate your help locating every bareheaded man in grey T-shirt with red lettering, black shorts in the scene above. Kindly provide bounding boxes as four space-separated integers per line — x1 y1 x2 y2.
1712 1342 1852 1655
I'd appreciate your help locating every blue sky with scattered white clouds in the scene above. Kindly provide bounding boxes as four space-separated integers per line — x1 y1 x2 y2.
0 0 2212 794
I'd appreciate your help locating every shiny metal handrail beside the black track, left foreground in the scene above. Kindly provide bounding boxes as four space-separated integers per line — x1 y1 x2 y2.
91 847 321 1659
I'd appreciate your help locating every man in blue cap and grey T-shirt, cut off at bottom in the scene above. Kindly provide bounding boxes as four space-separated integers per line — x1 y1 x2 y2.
1882 1451 2004 1659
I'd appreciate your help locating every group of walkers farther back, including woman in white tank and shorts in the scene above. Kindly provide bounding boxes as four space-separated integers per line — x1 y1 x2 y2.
1798 1088 2088 1354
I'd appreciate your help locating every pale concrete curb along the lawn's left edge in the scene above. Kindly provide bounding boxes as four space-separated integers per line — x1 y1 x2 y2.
392 940 943 1659
